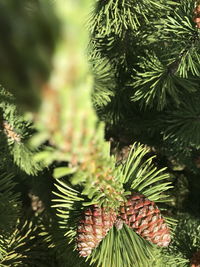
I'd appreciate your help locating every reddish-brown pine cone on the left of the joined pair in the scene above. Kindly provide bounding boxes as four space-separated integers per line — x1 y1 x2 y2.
77 205 116 257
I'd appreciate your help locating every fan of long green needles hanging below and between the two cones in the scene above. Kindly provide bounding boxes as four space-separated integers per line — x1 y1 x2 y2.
91 225 154 267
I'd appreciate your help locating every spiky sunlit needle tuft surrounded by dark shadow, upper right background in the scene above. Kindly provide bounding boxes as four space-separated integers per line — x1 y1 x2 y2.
132 51 199 110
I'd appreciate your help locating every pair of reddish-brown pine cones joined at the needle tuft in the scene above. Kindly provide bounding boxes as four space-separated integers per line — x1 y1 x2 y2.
77 193 170 257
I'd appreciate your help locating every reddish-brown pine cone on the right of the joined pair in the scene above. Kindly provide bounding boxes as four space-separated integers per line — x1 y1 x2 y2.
120 193 170 247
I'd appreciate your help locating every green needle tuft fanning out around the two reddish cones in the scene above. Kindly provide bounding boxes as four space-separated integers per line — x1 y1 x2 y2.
53 144 173 267
